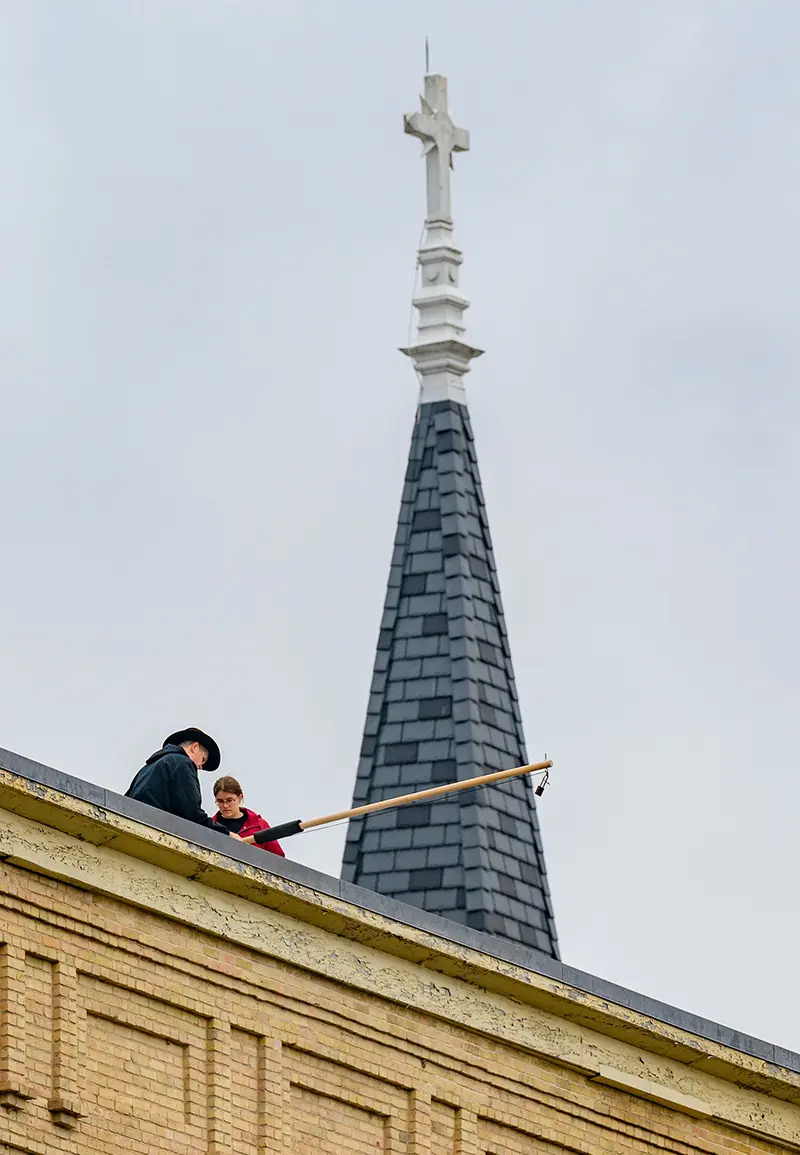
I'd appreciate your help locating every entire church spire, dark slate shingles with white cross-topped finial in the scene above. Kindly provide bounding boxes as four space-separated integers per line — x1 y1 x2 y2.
342 76 559 957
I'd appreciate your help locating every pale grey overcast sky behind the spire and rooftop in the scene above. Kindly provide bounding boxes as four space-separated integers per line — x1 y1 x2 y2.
0 0 800 1050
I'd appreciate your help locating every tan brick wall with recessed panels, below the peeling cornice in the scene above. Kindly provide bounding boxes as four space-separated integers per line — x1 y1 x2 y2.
0 856 800 1155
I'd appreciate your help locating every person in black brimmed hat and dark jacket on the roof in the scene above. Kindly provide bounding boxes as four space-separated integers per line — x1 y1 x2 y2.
126 726 238 839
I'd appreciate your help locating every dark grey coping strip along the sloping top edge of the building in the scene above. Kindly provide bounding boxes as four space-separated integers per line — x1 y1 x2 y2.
0 748 800 1073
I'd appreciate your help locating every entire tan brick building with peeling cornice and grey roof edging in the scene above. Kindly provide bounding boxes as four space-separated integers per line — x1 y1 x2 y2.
0 752 800 1155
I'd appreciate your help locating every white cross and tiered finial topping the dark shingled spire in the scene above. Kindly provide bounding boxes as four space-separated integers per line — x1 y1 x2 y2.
401 76 483 404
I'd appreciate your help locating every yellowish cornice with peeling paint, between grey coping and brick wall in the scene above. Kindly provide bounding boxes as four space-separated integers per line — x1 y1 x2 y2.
0 772 800 1149
